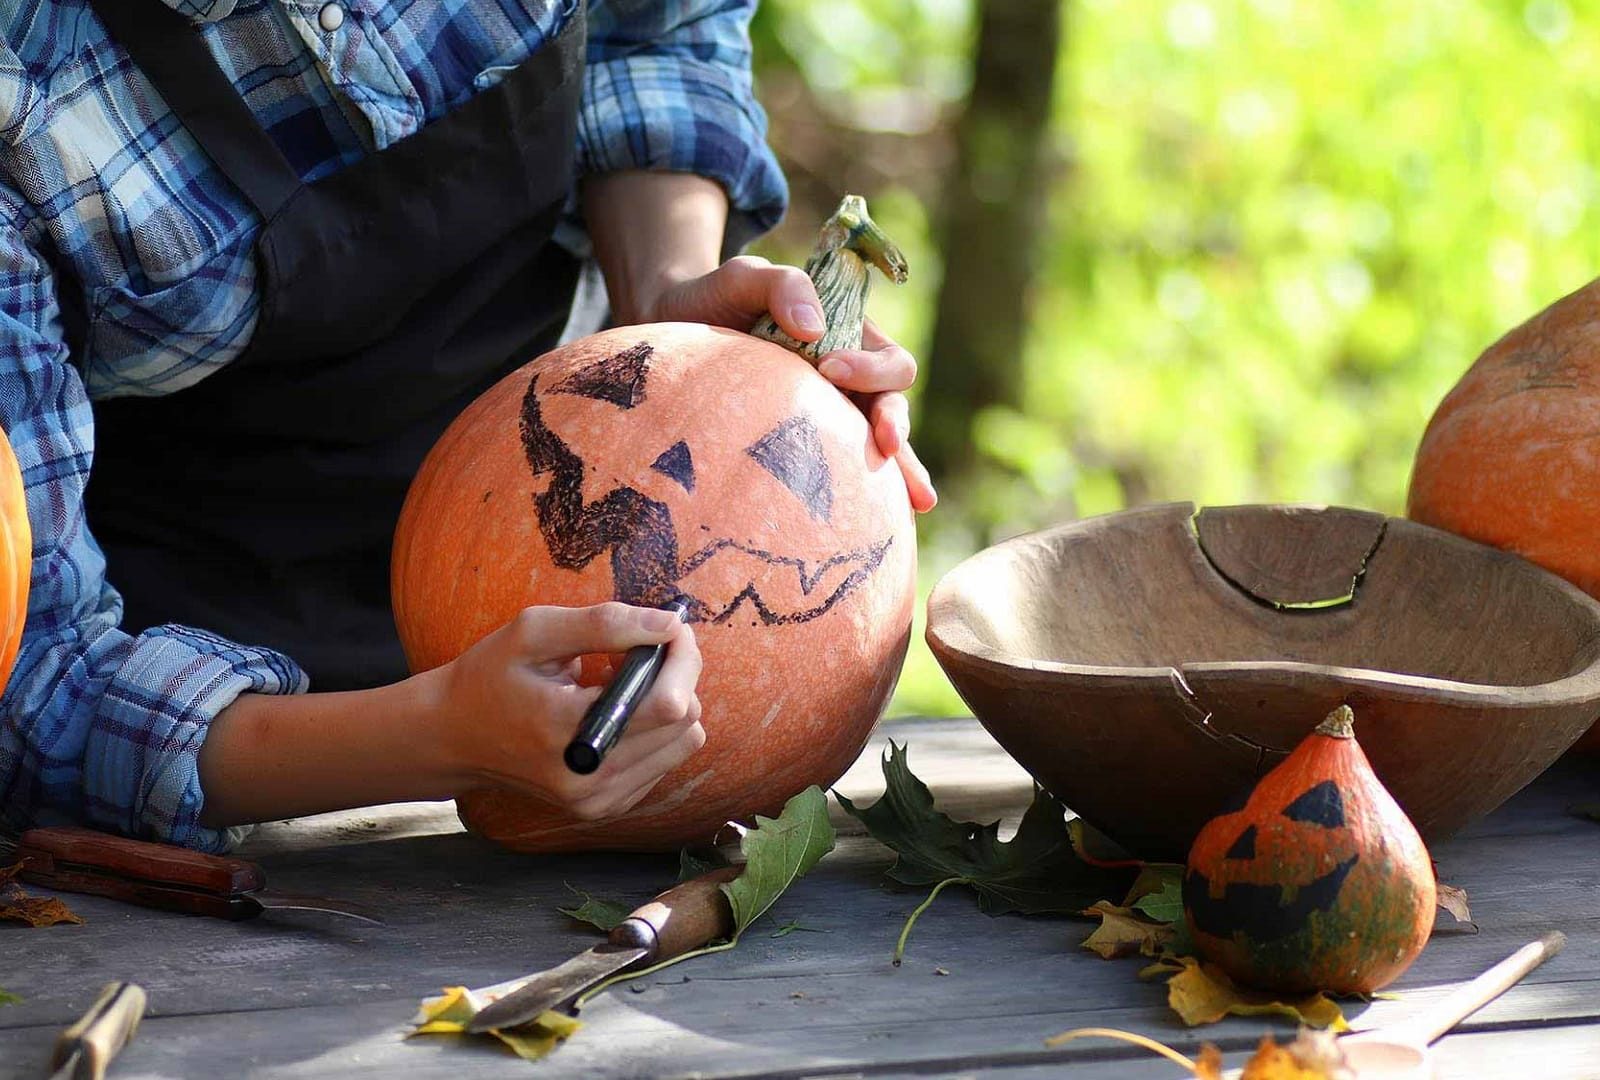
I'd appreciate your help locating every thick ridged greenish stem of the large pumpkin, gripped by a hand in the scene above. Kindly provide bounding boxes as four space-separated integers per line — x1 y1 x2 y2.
750 195 907 363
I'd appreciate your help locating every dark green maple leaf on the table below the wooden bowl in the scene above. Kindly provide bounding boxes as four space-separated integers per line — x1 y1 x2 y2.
834 739 1130 963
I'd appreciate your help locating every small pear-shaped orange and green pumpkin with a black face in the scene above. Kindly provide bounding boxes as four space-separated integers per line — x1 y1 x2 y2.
1184 706 1435 994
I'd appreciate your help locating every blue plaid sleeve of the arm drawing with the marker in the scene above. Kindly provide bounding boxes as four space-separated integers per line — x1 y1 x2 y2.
0 200 306 851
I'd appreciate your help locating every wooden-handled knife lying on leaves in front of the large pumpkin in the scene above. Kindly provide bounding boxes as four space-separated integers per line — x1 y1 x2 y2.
467 866 744 1034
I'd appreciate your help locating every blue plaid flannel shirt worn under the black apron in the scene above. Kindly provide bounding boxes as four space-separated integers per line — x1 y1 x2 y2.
0 0 787 851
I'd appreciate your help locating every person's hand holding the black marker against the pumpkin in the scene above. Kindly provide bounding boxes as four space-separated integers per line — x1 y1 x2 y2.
438 603 706 821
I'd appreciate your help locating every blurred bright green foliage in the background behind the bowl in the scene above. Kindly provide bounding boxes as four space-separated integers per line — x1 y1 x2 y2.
754 0 1600 726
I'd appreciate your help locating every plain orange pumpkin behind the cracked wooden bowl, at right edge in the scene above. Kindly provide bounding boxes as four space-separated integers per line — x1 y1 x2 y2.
1406 280 1600 750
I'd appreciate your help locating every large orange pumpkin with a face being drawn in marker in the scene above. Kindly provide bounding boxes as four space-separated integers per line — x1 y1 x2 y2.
392 196 917 851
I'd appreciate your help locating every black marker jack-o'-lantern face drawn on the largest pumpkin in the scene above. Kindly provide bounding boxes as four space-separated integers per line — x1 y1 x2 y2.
520 341 896 627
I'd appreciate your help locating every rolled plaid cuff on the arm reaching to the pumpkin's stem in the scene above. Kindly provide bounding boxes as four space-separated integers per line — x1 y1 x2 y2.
578 53 789 240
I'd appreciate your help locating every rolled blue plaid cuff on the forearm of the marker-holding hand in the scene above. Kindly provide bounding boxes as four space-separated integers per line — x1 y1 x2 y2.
83 626 307 853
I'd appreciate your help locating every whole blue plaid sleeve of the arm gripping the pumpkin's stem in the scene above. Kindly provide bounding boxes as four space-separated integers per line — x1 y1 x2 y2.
578 0 789 232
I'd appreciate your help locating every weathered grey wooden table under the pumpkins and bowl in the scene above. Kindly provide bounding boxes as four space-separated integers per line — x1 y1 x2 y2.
0 720 1600 1080
